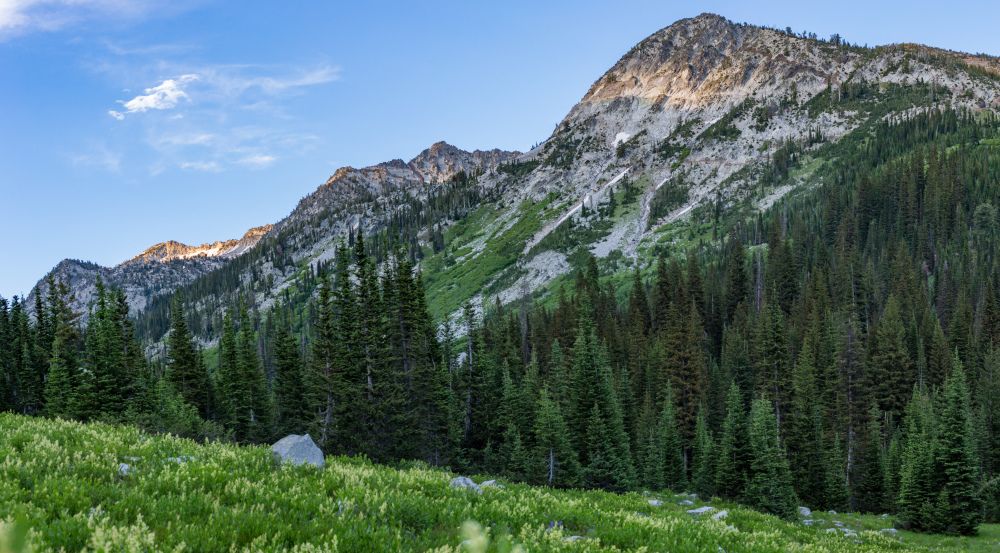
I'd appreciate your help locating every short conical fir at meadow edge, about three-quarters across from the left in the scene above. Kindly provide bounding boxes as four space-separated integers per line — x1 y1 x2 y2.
744 399 798 519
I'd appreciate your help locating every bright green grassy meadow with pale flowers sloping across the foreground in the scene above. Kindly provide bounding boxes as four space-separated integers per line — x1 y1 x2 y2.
9 414 1000 553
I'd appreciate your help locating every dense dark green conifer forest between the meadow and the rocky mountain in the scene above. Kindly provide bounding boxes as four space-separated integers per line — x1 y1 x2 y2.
0 111 1000 534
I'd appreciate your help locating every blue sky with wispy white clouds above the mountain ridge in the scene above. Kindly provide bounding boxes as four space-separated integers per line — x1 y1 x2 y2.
0 0 1000 297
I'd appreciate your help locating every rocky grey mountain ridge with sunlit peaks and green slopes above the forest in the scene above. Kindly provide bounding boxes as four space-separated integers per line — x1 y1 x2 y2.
29 14 1000 340
